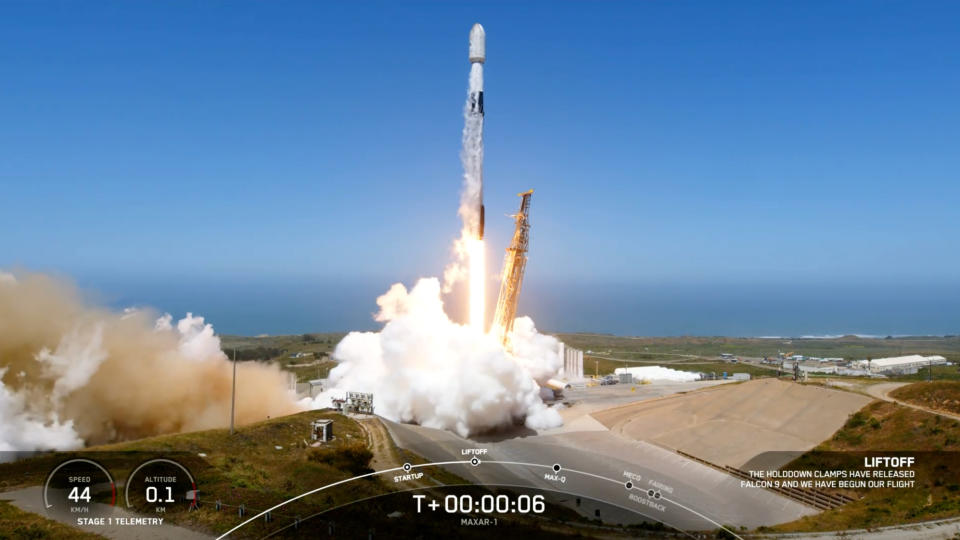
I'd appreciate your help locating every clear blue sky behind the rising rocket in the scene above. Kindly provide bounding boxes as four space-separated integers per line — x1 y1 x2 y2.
0 2 960 333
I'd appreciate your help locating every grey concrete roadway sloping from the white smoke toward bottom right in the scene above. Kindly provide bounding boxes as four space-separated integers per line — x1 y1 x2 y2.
378 383 816 530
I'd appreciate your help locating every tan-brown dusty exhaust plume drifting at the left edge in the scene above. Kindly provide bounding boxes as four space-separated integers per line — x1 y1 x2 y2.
0 272 299 450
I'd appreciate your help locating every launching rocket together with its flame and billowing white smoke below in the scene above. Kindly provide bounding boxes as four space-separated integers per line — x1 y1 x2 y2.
314 24 563 437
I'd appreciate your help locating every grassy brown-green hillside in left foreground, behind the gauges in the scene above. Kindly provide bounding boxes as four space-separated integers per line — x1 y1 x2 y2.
0 411 378 537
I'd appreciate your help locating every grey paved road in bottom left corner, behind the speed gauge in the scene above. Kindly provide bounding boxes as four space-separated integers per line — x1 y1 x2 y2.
0 486 213 540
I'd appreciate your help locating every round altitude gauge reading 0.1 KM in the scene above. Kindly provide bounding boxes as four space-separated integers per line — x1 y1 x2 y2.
124 458 198 516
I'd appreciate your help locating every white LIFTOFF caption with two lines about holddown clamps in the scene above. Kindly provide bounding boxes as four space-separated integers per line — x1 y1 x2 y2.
740 456 917 489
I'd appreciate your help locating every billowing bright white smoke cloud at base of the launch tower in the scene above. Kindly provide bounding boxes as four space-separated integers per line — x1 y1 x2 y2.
313 278 562 437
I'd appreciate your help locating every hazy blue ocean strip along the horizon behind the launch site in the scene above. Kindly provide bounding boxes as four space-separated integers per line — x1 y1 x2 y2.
79 277 960 337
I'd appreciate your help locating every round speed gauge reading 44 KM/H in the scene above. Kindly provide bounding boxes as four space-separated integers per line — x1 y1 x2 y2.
43 458 117 521
